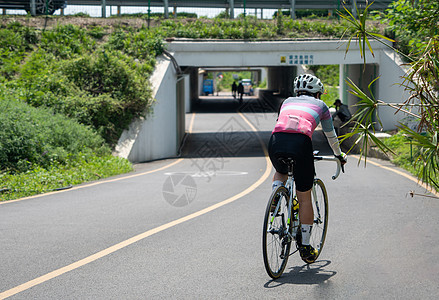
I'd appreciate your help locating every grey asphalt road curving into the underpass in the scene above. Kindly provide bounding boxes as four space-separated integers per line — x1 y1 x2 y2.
0 98 439 299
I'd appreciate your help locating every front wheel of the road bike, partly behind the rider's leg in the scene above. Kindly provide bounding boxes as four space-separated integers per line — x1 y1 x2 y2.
310 179 328 257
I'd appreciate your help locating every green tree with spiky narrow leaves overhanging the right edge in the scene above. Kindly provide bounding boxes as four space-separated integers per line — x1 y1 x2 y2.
339 0 439 190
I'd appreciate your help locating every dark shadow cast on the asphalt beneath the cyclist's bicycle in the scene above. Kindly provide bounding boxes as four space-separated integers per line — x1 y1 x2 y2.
264 260 337 288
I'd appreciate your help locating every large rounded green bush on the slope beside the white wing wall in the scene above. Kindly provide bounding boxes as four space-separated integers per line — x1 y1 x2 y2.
62 51 152 144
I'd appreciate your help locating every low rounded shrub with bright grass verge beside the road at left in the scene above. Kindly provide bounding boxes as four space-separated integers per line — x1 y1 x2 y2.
0 99 132 201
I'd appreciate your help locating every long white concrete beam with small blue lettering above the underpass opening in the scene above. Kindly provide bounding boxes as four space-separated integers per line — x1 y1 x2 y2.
167 39 385 68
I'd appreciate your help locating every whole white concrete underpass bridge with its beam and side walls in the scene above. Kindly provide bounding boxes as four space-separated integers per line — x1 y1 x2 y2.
116 39 408 162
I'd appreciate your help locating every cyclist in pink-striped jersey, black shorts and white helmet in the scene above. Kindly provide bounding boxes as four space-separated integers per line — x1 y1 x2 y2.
268 74 346 263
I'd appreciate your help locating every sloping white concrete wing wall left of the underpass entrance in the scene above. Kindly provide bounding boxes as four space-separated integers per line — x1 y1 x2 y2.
115 57 185 163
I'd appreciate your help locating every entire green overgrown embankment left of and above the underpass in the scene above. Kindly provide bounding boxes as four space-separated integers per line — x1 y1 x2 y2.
0 16 384 201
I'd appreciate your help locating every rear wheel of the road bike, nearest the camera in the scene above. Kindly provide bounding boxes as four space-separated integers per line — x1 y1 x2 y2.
262 186 291 279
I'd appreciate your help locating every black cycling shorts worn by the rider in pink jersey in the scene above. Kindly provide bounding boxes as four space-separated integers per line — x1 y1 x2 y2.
268 132 315 192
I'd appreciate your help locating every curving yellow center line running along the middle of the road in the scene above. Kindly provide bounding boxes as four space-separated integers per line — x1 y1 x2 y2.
0 114 272 299
